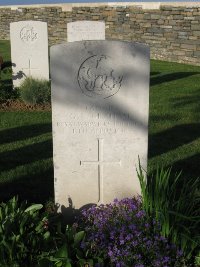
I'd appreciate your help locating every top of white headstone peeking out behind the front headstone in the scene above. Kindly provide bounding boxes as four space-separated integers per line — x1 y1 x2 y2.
67 20 105 42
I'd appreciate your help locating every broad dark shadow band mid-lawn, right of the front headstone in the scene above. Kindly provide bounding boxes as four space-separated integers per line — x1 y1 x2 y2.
148 123 200 159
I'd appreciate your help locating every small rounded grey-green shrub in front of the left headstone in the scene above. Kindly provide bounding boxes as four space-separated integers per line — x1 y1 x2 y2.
19 78 51 105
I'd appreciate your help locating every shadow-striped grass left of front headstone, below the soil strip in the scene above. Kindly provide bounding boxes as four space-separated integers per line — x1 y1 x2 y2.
0 112 53 202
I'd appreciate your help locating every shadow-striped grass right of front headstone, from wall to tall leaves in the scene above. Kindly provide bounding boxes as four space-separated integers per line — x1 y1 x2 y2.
149 60 200 182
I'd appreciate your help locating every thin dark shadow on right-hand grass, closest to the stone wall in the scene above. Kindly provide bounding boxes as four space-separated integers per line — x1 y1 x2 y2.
150 72 200 86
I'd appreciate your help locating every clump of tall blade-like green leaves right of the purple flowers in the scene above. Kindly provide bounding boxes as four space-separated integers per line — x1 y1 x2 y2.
138 163 200 261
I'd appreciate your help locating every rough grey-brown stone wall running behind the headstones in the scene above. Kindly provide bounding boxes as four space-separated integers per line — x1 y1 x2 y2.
0 3 200 65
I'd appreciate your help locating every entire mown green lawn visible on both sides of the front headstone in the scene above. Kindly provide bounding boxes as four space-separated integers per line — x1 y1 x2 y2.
0 41 200 202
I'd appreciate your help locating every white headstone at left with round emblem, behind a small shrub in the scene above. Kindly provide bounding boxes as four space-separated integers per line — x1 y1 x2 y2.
10 21 49 87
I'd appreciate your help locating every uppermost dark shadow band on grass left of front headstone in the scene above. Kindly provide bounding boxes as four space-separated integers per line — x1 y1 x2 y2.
0 123 52 145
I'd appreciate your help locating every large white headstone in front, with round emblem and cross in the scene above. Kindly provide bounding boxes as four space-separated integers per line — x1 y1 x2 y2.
51 41 150 208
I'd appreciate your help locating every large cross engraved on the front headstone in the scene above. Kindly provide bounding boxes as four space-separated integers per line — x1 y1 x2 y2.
80 139 121 204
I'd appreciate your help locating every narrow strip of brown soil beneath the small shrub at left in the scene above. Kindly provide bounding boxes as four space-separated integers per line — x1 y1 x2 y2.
0 99 51 111
